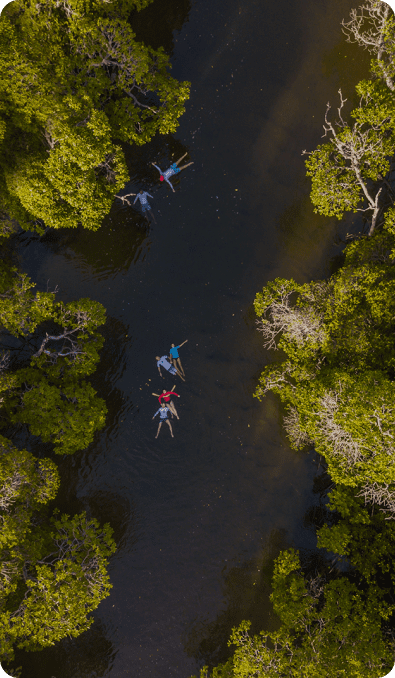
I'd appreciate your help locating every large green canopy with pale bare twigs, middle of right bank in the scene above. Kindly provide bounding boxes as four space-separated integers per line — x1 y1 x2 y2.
255 233 395 498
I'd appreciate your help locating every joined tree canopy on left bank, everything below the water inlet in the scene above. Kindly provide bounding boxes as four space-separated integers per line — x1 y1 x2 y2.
0 257 115 661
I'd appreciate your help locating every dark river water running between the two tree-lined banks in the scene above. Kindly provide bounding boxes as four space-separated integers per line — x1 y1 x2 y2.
8 0 369 678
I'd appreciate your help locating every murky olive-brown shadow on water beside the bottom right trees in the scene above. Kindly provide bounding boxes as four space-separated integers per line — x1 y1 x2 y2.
184 529 289 668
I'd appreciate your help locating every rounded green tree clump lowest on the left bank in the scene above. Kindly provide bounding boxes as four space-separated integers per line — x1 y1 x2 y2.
0 514 115 654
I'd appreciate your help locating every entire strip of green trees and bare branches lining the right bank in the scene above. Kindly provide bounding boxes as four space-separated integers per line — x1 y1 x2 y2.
195 0 395 678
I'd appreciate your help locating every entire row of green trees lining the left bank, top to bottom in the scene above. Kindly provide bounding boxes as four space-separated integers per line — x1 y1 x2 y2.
0 0 189 662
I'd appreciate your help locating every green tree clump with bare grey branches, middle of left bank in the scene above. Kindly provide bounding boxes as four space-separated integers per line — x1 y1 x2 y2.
0 264 107 454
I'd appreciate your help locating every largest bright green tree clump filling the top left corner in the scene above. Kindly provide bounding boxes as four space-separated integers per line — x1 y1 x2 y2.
0 0 189 231
